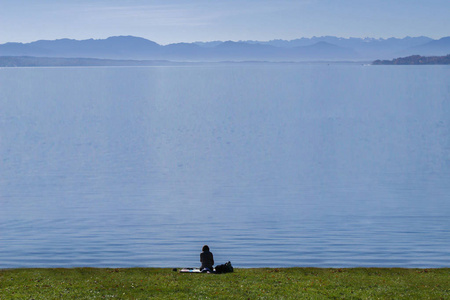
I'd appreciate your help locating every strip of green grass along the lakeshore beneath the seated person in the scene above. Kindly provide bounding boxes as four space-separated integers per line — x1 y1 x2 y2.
0 268 450 300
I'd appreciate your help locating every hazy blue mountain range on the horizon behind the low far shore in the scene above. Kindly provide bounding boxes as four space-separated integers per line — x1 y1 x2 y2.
0 36 450 61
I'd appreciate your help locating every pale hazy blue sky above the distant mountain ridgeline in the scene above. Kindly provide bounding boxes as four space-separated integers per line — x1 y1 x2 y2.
0 0 450 44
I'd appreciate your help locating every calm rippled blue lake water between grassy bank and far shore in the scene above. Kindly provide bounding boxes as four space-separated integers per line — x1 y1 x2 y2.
0 64 450 268
